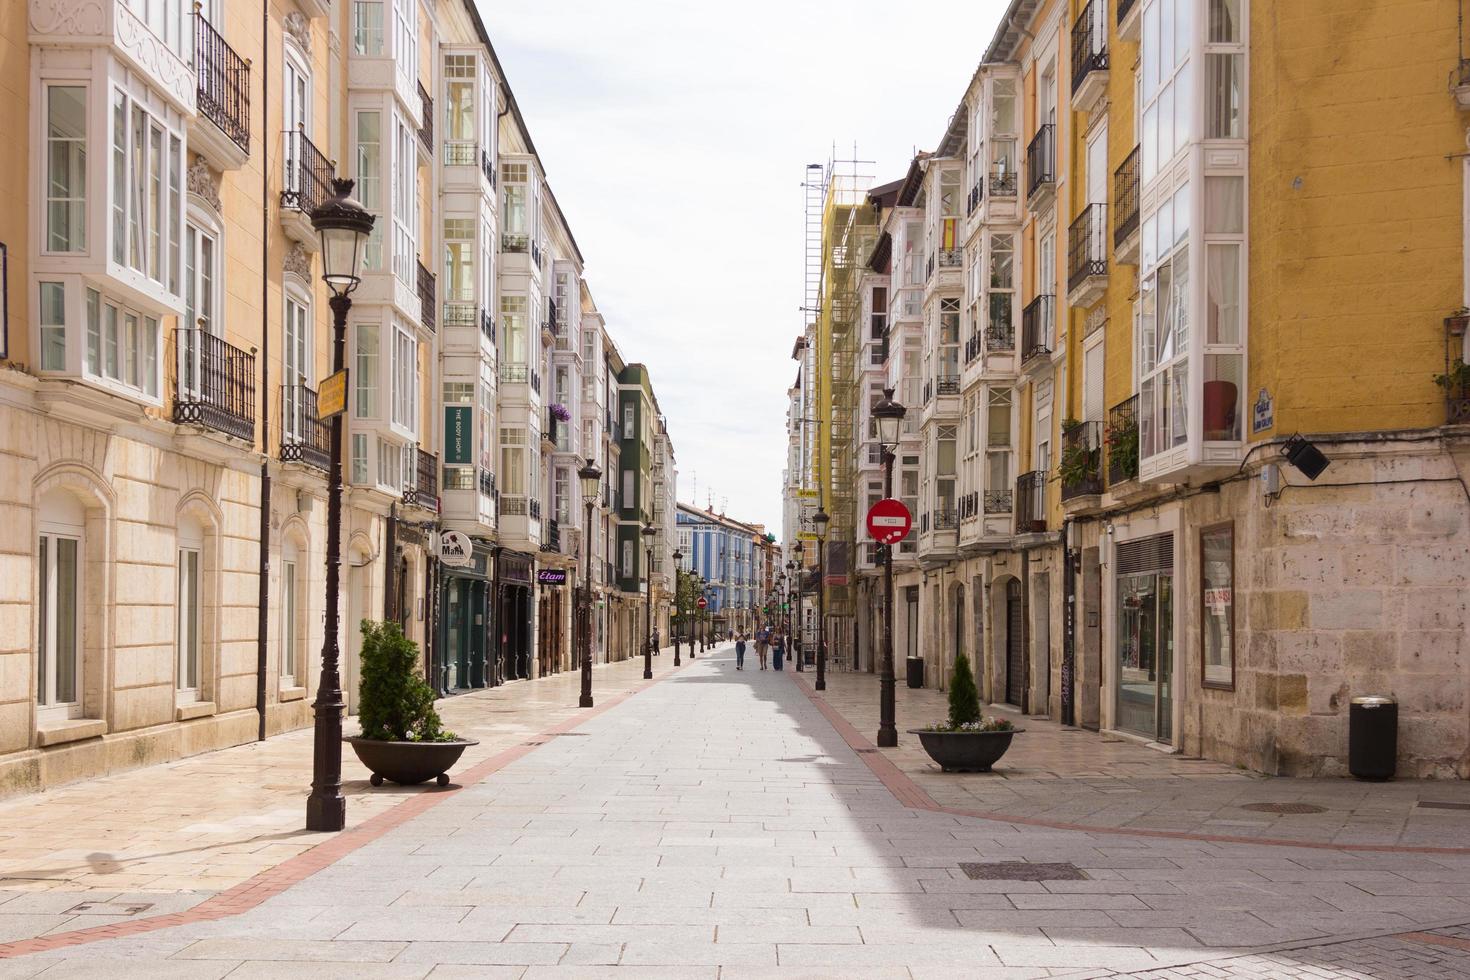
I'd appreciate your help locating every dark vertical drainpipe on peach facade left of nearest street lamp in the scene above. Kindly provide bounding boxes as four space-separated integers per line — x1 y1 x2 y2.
256 3 270 742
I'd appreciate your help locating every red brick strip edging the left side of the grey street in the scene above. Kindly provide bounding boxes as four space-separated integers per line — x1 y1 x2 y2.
0 671 673 959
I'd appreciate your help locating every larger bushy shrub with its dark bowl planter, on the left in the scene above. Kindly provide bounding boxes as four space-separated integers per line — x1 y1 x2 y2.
347 620 478 786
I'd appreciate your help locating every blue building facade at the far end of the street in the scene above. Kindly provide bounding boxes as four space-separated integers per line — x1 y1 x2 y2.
676 504 763 632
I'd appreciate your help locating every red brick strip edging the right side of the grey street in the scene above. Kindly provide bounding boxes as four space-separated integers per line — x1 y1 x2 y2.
788 671 1470 852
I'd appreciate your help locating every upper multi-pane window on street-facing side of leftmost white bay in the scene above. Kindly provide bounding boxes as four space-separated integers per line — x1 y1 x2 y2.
110 90 184 294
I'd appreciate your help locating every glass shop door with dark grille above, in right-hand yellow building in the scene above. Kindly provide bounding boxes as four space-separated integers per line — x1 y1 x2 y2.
1116 535 1175 742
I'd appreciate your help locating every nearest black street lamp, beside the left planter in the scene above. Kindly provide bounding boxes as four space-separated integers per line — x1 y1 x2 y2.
306 178 375 830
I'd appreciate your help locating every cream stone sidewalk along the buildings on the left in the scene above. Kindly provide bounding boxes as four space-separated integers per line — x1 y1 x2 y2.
0 649 687 946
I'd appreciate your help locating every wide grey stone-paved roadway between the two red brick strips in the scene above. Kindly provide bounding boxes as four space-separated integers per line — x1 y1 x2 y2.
0 643 1470 980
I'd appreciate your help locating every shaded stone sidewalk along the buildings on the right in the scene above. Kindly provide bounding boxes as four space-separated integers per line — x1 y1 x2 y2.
806 673 1470 848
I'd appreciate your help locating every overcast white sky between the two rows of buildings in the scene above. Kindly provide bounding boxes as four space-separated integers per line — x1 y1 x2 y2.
478 0 1005 535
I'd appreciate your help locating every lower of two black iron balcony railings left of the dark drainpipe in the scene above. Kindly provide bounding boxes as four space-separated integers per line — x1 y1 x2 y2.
173 328 256 442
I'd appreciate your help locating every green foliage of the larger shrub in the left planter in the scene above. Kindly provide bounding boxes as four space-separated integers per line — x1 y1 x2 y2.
357 620 456 742
